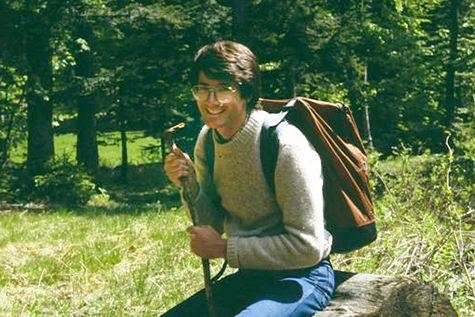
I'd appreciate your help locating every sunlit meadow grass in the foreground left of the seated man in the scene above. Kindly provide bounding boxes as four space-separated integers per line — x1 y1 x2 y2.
0 205 218 316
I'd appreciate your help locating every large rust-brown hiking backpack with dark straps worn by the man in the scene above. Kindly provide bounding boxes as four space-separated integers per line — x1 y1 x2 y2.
205 97 377 253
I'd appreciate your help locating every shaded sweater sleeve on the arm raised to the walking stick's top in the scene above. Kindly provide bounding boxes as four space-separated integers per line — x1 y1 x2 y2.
181 126 224 233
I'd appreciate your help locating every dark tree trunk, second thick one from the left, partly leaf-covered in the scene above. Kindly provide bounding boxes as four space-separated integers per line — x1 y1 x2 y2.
75 21 99 178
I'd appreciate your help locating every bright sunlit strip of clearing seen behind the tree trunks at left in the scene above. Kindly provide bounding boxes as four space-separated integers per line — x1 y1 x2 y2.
11 131 161 167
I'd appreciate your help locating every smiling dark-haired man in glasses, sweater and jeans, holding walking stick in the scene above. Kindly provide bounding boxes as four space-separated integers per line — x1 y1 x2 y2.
163 41 335 317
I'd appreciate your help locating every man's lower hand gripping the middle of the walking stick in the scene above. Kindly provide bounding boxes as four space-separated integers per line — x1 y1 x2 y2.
186 226 227 259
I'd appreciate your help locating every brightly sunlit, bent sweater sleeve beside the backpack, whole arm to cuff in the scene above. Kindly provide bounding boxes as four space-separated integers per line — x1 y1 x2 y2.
228 125 331 270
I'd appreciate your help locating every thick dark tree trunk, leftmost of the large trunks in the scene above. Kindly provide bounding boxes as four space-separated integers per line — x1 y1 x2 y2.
25 15 54 176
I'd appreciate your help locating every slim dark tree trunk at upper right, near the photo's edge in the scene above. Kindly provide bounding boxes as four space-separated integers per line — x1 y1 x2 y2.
445 0 460 127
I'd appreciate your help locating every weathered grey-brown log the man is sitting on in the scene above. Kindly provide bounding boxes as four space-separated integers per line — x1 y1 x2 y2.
314 271 457 317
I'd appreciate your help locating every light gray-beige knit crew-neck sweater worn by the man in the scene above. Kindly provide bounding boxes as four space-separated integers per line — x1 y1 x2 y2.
186 110 332 270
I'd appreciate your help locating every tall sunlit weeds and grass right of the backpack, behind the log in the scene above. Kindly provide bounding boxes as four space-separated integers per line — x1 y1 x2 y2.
333 136 475 317
